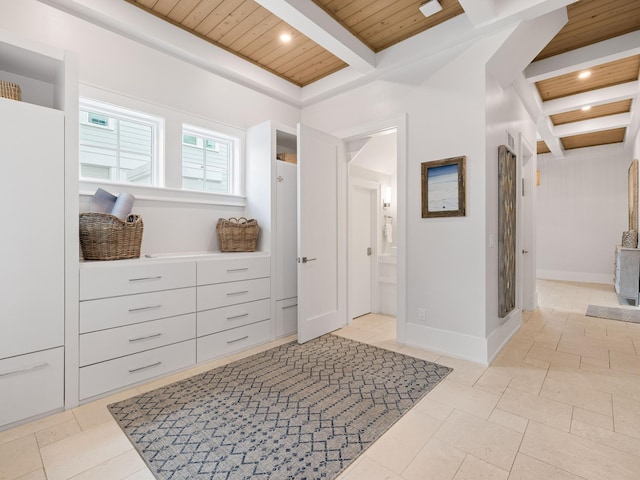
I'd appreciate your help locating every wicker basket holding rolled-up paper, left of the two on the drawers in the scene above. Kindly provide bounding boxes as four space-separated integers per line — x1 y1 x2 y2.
80 212 144 260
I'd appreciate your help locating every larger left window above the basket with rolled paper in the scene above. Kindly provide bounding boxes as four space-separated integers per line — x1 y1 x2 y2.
80 99 163 186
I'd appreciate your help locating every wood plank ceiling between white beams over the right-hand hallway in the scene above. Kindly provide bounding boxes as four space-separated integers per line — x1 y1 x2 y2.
534 0 640 153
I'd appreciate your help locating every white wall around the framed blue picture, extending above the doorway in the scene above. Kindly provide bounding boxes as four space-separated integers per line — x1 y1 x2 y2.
302 34 506 362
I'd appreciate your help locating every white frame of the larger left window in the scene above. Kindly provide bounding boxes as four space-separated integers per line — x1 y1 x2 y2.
79 97 165 188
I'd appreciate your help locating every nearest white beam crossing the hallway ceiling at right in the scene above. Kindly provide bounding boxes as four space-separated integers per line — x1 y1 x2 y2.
524 30 640 83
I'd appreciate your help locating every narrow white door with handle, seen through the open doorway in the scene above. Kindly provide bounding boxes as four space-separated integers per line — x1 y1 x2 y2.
349 185 376 318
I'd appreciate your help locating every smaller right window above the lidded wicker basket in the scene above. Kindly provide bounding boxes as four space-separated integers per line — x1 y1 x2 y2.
182 125 240 194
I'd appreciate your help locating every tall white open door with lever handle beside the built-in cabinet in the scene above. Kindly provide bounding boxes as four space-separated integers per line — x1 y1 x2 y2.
298 125 347 343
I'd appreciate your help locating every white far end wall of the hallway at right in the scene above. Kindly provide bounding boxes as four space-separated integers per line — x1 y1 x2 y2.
537 148 631 284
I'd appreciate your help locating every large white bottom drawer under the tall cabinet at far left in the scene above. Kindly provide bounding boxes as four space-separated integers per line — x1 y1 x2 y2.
0 347 64 426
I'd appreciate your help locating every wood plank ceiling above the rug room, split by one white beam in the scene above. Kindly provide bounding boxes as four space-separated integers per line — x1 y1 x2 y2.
125 0 463 87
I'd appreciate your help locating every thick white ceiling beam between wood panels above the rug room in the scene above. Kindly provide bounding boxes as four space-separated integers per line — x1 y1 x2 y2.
256 0 376 73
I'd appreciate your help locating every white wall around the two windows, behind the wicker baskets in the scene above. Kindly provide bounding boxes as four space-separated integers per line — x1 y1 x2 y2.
0 0 300 252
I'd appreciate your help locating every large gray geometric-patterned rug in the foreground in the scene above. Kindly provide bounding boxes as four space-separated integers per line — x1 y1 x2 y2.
109 335 452 480
